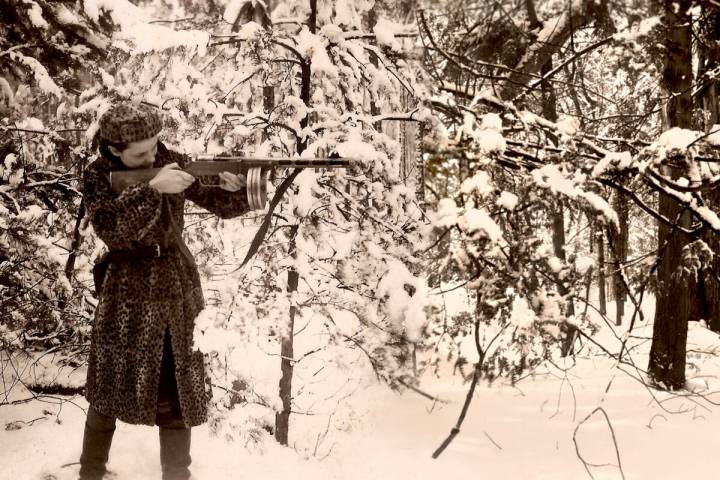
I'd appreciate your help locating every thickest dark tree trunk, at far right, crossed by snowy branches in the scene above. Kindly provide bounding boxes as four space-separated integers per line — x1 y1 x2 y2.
648 0 697 390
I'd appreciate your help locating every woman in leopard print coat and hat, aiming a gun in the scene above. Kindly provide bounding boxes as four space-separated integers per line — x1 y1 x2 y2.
80 102 248 480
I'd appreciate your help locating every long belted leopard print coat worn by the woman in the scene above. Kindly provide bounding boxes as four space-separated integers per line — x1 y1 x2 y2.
83 143 248 426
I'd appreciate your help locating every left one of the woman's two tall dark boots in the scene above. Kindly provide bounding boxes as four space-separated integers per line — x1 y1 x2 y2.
79 407 115 480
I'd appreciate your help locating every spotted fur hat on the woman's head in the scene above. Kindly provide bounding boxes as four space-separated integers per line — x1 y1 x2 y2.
99 102 162 143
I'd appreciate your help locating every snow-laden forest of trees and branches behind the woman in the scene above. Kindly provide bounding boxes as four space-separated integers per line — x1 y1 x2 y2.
0 0 720 476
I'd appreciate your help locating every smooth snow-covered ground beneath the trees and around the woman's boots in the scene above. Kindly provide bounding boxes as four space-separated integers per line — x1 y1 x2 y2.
0 296 720 480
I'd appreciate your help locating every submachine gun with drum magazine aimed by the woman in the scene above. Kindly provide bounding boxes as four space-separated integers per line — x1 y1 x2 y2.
110 154 356 210
